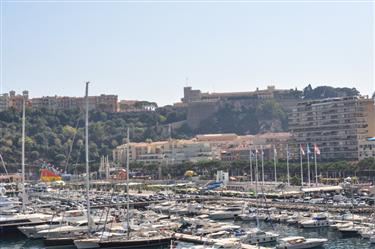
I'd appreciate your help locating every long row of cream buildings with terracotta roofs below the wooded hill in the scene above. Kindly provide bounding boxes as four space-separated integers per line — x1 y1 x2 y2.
113 133 292 164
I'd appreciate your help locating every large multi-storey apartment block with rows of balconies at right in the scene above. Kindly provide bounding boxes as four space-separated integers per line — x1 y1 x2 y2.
288 97 375 160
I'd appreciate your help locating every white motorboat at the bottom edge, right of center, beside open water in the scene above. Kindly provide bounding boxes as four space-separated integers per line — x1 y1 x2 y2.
276 236 327 249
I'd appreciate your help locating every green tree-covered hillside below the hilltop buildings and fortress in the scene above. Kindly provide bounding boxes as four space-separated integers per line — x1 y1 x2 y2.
0 84 358 168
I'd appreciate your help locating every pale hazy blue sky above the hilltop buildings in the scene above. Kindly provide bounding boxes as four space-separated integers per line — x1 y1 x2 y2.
1 0 374 104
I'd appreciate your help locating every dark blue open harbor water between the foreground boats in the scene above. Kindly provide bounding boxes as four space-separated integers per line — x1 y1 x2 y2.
0 222 375 249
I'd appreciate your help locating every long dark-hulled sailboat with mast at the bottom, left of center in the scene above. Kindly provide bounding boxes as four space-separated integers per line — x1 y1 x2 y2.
74 128 172 249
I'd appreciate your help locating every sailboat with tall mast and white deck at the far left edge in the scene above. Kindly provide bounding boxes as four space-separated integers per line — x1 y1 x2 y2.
0 96 52 234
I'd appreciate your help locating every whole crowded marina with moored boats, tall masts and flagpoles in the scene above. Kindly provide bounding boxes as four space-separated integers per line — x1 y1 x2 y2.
0 77 375 249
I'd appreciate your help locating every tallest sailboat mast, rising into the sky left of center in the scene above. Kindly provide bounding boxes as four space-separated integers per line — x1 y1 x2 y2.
85 82 91 234
